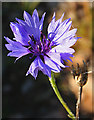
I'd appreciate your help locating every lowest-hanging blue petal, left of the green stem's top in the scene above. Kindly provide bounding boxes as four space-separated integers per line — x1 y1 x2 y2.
26 57 51 79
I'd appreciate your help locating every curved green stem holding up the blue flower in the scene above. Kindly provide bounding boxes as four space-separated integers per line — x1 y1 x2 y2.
49 73 76 120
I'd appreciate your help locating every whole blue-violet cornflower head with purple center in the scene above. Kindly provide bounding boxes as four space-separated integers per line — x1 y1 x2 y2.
4 9 78 79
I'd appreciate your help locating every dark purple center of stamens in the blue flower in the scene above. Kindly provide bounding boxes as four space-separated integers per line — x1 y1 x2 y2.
27 33 52 56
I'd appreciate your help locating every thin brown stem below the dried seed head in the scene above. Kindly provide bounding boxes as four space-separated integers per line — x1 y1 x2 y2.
76 86 82 120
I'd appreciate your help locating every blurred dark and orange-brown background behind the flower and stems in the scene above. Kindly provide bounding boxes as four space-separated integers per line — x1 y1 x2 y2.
2 2 94 119
